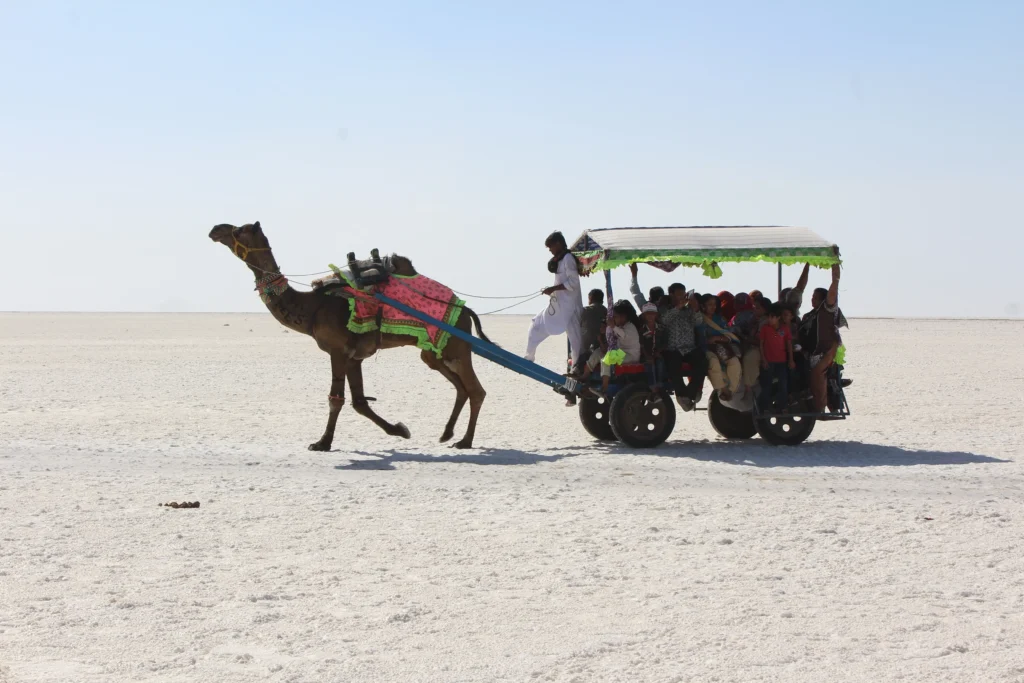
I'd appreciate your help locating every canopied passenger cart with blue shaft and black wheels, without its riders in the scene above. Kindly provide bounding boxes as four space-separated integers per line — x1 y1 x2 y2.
373 226 850 449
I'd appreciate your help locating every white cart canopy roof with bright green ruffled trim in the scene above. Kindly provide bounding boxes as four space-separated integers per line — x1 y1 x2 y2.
569 225 840 278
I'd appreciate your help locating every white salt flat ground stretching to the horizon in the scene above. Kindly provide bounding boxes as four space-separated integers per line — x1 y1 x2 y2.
0 314 1024 683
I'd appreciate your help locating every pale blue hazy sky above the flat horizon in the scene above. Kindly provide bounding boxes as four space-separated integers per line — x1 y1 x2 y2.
0 1 1024 316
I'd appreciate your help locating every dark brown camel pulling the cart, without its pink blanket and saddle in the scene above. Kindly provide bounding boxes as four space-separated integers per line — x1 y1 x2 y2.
210 221 489 451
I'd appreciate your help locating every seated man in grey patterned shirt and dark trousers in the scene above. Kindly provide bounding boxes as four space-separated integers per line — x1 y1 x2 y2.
662 283 708 412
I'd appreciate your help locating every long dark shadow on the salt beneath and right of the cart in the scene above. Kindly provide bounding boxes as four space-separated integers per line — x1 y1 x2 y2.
646 439 1013 467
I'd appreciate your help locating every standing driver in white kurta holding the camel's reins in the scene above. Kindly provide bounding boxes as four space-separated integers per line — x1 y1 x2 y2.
526 232 586 364
